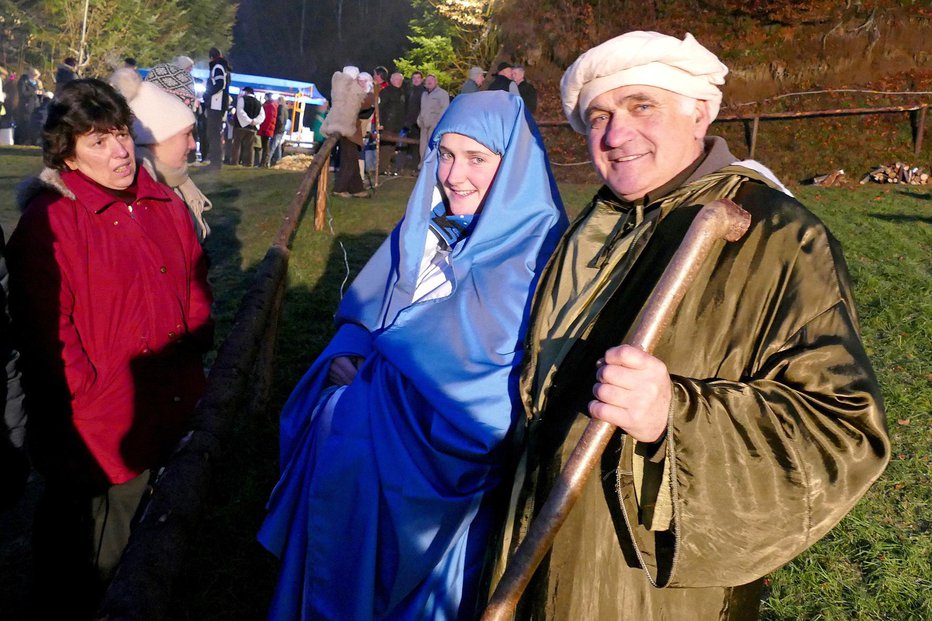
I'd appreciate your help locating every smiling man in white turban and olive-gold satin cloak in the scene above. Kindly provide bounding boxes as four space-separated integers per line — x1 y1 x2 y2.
496 32 889 621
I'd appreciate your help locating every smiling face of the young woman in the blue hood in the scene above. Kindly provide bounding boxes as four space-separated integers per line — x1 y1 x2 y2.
437 133 502 216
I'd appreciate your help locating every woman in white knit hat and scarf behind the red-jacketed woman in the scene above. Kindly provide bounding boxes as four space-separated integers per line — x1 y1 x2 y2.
110 63 211 242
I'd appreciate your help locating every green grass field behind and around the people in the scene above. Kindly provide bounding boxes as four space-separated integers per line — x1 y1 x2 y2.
0 148 932 621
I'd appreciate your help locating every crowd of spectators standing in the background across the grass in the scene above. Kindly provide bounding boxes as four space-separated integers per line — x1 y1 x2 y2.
0 54 537 182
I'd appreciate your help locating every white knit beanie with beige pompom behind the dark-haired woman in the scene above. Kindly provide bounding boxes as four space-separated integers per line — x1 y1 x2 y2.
110 69 195 145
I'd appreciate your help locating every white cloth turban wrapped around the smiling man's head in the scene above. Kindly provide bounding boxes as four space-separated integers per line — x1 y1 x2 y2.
560 30 728 134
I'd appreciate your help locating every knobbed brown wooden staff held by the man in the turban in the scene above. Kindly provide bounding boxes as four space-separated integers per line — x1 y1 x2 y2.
482 199 751 621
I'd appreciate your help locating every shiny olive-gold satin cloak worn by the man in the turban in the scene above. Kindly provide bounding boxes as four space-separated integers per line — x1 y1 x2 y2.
506 168 889 621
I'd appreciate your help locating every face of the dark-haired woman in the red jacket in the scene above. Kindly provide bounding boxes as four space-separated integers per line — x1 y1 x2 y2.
65 127 136 190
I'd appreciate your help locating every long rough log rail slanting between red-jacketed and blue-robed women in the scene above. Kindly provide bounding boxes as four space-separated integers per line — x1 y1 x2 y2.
97 137 337 621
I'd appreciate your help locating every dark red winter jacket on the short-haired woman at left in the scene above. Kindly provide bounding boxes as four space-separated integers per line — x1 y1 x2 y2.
7 168 213 483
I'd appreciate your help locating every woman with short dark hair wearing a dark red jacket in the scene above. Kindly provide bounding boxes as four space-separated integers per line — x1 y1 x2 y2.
7 79 213 619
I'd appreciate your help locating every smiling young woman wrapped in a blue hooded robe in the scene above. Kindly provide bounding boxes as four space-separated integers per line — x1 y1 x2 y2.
259 91 566 621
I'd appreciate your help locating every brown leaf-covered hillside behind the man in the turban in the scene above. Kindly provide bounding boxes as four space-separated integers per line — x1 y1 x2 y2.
496 0 932 180
